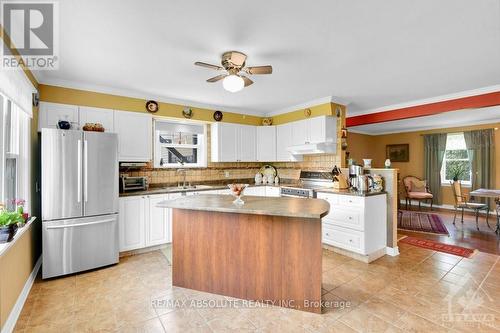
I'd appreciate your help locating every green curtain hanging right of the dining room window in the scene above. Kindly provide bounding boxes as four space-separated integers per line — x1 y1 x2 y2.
464 128 495 202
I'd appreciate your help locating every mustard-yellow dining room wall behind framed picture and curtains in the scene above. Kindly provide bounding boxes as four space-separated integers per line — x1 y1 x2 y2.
347 122 500 205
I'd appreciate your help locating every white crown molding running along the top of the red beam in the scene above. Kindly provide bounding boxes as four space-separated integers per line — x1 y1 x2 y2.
348 84 500 117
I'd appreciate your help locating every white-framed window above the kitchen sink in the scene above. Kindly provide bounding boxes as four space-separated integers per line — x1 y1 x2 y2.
154 120 207 168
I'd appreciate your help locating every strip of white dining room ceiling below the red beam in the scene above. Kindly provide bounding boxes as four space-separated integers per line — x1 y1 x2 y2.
349 106 500 135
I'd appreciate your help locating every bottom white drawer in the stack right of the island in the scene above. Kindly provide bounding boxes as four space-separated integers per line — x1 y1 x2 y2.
322 224 365 254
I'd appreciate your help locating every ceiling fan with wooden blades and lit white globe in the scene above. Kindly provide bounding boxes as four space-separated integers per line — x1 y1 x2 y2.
194 51 273 92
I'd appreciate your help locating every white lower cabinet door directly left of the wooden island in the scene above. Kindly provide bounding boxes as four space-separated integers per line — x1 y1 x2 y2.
145 194 170 246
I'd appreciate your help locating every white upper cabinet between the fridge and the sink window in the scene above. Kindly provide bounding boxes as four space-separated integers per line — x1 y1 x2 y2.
114 110 153 162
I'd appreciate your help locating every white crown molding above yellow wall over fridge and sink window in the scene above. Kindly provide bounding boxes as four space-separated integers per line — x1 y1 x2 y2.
40 79 264 117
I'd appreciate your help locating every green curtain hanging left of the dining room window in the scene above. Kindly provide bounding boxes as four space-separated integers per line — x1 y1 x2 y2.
424 133 447 205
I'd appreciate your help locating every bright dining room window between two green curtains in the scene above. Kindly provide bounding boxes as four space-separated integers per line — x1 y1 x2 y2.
441 133 472 185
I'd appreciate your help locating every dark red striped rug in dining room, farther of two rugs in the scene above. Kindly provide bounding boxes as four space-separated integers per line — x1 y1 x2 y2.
398 210 449 235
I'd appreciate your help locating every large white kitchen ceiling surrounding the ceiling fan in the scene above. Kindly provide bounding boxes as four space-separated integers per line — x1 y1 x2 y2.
35 0 500 115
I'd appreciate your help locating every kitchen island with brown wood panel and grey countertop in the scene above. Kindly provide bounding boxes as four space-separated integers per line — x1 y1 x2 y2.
158 194 330 313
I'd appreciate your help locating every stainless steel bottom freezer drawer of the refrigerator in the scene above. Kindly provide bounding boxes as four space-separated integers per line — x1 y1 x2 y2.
42 214 118 279
